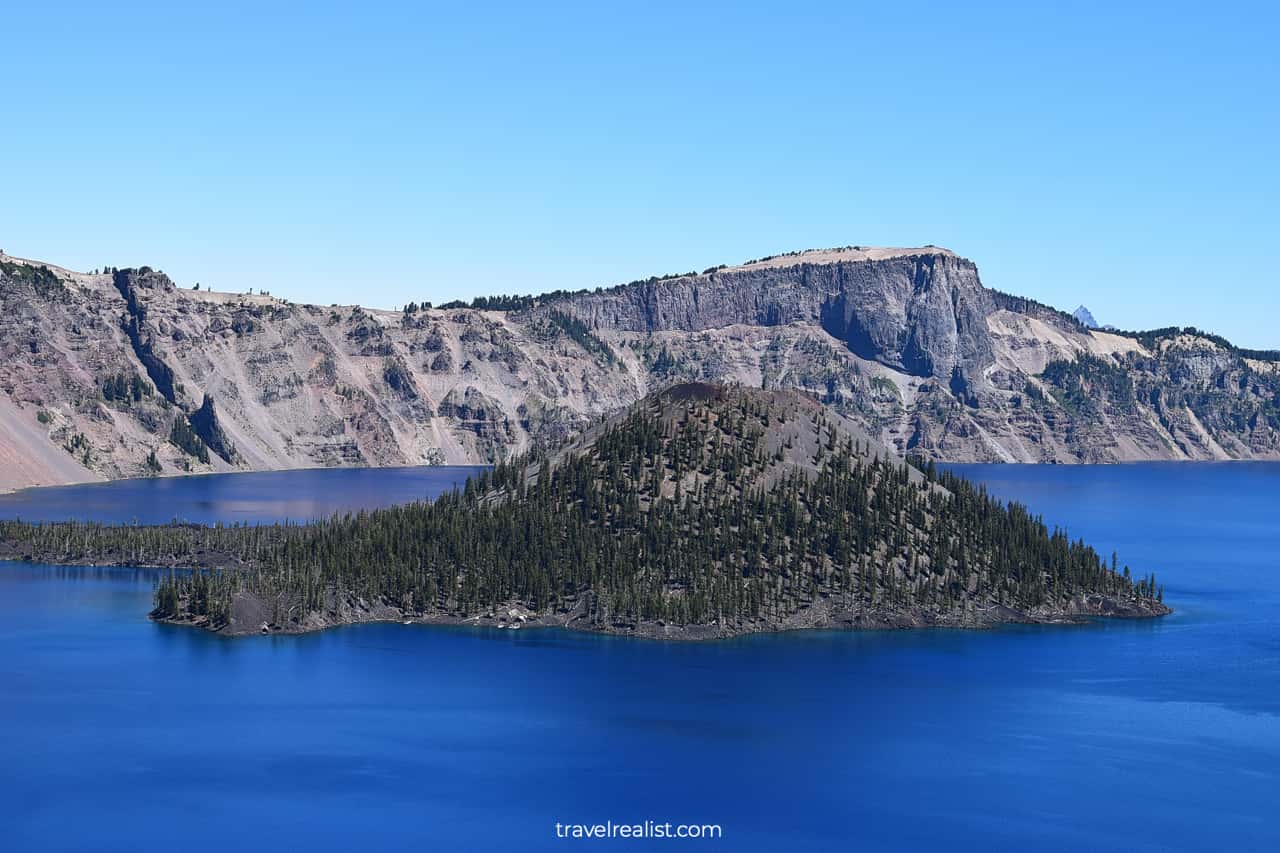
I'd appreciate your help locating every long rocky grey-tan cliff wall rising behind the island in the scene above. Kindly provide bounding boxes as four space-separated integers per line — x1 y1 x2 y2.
0 247 1280 488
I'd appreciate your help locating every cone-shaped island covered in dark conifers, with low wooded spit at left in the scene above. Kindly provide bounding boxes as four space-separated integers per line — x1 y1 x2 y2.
0 383 1169 639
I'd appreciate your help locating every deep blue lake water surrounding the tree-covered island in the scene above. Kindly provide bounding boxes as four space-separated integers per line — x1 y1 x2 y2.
0 464 1280 852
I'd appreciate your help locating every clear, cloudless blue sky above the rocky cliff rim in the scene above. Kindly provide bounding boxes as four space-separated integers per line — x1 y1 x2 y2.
0 0 1280 347
